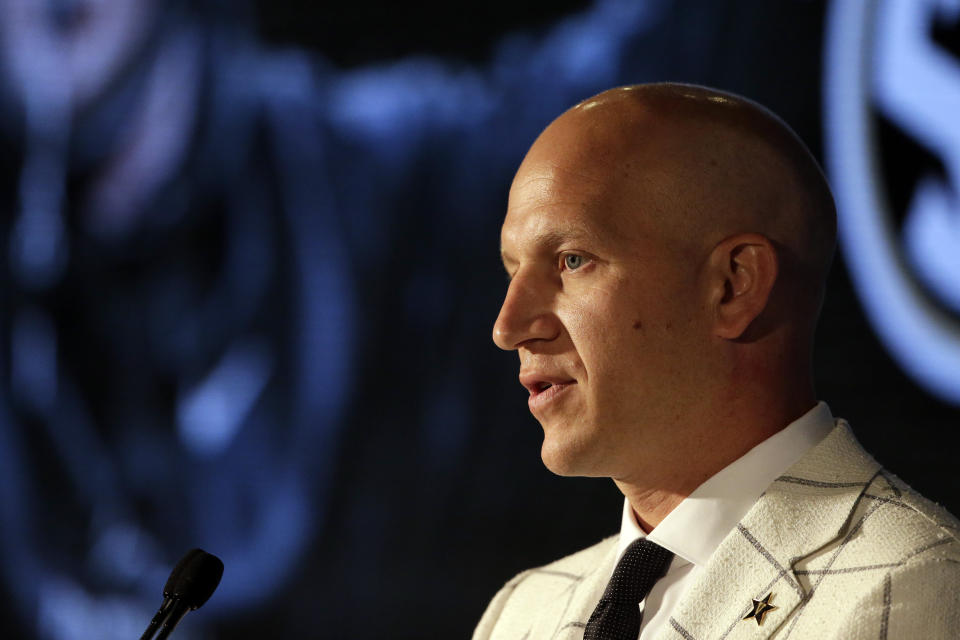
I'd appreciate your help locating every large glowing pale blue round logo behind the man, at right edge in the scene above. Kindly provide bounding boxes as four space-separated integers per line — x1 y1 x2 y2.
824 0 960 404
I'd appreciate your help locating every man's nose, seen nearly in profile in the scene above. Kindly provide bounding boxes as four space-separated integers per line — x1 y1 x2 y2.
493 273 560 351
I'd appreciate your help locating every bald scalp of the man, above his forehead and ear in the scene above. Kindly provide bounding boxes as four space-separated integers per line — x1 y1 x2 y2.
517 83 836 308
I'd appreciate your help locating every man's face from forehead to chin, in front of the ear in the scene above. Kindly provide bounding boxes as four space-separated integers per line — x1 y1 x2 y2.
493 118 707 480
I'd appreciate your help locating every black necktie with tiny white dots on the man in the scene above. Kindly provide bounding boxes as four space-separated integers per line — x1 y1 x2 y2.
583 538 673 640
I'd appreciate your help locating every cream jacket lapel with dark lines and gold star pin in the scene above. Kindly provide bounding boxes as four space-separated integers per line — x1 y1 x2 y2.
657 421 880 640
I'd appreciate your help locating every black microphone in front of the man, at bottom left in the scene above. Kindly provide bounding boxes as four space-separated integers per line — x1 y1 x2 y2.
140 549 223 640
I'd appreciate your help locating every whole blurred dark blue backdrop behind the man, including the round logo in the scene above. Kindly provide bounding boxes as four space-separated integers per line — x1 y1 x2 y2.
0 0 960 640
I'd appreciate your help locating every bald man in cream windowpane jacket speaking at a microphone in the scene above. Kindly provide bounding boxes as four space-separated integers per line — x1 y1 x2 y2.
474 84 960 640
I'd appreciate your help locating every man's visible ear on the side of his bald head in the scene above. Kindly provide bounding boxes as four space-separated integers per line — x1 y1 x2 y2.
708 233 779 340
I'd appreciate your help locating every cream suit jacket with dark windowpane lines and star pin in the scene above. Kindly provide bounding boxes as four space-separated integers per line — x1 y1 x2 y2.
473 420 960 640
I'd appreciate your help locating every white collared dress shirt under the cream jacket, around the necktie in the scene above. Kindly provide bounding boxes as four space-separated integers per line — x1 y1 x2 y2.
617 402 833 640
